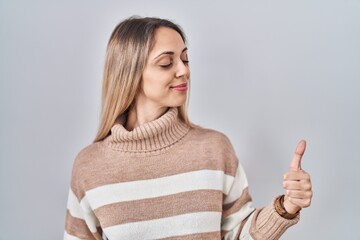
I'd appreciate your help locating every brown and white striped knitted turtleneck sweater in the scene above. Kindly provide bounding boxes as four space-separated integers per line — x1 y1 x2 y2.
64 108 299 240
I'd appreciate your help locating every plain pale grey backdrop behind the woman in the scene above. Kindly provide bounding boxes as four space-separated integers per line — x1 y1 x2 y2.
0 0 360 240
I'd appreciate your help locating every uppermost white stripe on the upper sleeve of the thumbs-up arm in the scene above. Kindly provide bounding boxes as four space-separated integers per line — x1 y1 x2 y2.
224 163 248 204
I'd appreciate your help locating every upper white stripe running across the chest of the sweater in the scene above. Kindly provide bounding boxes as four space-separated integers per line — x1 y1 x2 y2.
86 170 234 209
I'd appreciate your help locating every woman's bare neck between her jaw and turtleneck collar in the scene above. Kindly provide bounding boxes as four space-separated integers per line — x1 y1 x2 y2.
125 104 168 131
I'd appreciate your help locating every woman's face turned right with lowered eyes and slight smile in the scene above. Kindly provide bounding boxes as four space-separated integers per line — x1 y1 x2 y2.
136 27 190 108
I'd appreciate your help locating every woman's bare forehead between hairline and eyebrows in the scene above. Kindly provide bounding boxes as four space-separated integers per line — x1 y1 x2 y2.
150 27 185 55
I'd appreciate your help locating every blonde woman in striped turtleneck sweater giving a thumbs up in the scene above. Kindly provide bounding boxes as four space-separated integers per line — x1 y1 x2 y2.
64 18 312 240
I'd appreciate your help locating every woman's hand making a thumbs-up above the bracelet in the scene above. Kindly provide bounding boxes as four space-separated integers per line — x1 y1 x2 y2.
283 140 313 214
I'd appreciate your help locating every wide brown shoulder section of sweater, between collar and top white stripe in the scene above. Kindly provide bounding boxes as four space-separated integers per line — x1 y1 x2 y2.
71 128 238 200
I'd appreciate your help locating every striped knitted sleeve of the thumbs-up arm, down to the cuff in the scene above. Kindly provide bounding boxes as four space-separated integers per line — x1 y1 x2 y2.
221 164 299 240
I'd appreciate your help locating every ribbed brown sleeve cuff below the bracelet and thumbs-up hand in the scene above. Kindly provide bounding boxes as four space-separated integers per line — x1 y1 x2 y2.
250 198 300 240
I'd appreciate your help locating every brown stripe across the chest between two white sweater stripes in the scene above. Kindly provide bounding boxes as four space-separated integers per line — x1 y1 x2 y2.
95 190 222 228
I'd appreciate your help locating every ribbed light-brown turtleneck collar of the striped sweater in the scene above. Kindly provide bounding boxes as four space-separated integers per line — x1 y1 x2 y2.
104 108 190 153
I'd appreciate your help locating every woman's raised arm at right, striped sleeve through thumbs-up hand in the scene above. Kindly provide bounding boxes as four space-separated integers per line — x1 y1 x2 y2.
223 141 312 240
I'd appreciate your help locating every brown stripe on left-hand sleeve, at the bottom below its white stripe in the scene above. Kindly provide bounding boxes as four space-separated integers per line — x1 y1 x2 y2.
65 210 101 239
